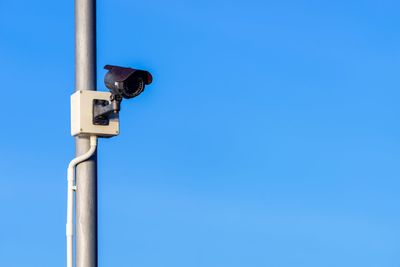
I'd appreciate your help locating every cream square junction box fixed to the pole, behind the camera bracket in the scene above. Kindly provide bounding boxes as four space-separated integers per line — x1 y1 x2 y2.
71 90 119 137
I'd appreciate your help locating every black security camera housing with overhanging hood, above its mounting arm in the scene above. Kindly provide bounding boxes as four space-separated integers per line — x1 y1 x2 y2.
104 65 153 99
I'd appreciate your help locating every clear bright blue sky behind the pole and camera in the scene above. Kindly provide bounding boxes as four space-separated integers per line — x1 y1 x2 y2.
0 0 400 267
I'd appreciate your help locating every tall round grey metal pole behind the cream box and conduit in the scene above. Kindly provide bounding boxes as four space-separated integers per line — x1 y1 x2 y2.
75 0 97 267
